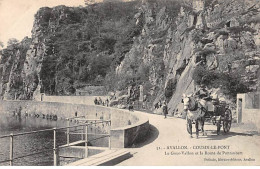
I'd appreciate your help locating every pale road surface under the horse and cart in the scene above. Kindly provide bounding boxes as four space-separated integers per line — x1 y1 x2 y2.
118 112 260 166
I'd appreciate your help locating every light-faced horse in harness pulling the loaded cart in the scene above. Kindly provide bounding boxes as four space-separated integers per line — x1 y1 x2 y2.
182 94 207 138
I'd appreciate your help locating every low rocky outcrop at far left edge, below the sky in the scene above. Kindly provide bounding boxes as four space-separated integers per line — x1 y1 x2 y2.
0 38 31 99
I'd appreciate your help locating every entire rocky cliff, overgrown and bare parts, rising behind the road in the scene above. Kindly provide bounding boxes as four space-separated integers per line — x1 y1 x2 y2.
0 0 260 113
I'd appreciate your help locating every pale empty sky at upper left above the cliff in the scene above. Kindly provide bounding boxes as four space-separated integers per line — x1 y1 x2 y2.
0 0 84 47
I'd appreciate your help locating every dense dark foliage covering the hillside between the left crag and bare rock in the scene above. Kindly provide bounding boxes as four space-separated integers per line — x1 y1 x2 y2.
38 2 142 95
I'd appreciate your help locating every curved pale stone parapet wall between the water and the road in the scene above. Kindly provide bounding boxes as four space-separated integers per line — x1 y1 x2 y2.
0 101 149 148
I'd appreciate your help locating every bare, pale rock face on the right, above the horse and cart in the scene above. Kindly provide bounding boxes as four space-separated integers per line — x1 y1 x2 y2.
114 0 260 113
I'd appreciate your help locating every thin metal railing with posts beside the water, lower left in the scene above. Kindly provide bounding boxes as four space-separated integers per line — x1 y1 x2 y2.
0 117 111 166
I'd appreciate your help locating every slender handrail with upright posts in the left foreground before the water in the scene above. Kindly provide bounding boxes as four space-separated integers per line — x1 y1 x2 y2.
0 120 111 166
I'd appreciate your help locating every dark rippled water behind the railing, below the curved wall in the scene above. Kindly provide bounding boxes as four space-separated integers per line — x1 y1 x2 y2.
0 114 108 166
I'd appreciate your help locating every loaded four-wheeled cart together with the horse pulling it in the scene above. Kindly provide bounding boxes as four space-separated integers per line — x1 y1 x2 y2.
183 95 232 137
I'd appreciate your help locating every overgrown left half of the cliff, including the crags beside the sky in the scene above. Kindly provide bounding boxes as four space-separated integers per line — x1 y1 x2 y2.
0 2 141 99
